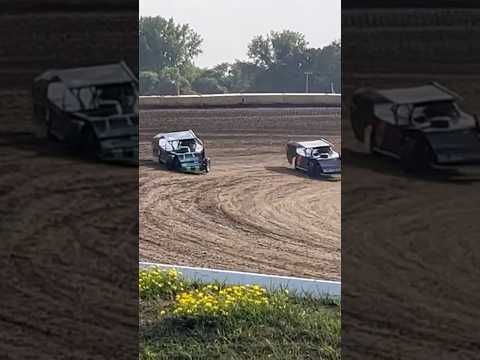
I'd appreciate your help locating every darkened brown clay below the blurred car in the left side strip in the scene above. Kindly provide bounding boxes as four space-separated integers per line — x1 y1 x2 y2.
0 90 138 359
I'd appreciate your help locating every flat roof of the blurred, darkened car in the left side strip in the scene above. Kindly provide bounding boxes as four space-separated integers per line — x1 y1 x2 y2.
37 62 137 88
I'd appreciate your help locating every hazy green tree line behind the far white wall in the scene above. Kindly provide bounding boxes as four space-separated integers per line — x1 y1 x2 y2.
139 16 341 95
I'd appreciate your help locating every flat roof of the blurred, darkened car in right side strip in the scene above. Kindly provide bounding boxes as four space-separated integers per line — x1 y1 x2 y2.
377 85 456 105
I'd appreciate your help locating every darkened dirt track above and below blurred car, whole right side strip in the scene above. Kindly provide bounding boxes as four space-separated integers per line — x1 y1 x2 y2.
342 10 480 360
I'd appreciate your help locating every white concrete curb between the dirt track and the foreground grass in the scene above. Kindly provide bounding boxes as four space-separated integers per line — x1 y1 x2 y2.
140 262 341 298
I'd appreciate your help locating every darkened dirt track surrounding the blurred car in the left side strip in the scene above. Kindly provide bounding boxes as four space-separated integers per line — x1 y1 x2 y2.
0 7 138 360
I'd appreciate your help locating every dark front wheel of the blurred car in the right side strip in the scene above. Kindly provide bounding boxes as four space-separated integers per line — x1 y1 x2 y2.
400 136 431 173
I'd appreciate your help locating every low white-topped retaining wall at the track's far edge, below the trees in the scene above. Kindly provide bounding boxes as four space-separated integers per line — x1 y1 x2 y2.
139 93 341 108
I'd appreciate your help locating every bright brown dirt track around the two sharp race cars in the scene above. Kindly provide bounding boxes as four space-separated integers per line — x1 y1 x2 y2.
140 108 341 279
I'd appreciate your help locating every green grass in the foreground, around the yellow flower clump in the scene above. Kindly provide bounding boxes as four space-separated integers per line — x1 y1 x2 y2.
139 268 341 360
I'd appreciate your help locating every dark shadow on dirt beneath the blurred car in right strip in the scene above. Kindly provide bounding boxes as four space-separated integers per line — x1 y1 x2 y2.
342 148 480 185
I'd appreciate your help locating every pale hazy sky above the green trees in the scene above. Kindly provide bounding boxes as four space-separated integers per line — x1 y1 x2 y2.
140 0 341 67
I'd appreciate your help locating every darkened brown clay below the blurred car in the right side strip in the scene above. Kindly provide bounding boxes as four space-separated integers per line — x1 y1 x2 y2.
342 79 480 360
